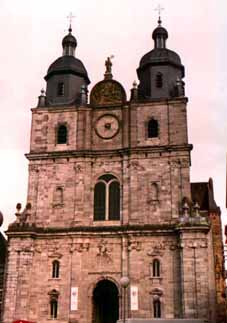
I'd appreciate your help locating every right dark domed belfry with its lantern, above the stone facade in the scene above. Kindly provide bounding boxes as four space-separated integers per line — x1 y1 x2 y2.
137 18 184 101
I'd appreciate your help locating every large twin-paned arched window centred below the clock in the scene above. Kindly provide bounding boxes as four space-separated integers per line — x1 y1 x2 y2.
94 174 120 221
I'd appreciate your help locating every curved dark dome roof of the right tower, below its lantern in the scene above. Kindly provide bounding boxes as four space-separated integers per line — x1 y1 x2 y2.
139 48 183 75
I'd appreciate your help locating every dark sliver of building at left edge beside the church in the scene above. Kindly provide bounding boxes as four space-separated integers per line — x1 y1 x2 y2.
0 212 7 322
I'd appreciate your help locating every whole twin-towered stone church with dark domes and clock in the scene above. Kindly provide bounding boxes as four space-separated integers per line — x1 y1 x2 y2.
1 20 225 323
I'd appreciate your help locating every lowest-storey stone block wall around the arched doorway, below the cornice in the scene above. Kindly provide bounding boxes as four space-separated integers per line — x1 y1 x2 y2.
4 229 214 323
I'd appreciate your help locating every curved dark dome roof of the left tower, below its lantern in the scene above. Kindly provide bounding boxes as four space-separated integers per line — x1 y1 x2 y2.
45 56 90 84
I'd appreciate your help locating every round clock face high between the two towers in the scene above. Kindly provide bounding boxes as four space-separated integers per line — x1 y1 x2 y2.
95 114 119 139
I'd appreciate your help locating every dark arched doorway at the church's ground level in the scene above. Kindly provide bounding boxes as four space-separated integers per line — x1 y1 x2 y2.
92 279 119 323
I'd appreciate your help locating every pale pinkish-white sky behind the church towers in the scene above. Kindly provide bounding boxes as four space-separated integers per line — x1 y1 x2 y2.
0 0 227 235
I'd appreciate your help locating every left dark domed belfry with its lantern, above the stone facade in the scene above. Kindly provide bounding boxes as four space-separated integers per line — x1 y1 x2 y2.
45 26 90 106
